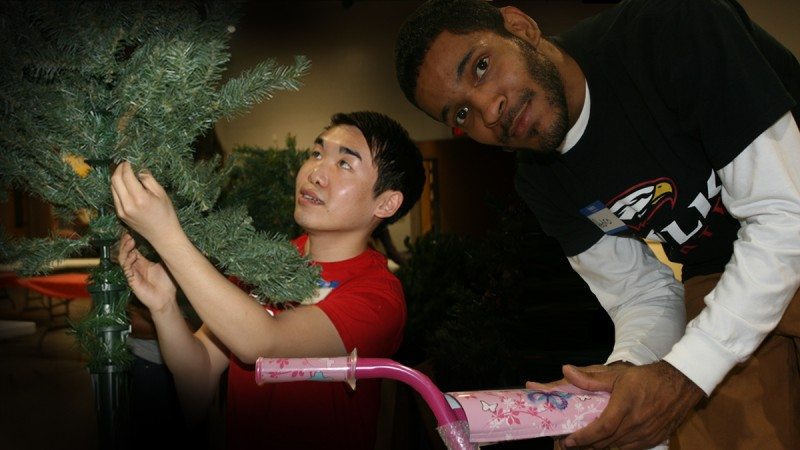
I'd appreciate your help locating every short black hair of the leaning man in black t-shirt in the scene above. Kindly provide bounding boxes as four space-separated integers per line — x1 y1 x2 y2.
394 0 511 107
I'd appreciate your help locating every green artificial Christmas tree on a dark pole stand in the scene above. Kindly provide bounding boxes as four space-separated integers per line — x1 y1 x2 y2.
0 1 318 448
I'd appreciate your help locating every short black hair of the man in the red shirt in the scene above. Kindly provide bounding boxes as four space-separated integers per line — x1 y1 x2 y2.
330 111 425 229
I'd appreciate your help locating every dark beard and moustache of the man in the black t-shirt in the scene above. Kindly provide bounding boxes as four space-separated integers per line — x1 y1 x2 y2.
500 37 569 154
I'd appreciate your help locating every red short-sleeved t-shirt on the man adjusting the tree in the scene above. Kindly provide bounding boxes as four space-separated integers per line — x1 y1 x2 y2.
226 235 406 450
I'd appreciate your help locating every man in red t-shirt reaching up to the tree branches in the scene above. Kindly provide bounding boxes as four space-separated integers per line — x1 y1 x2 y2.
111 112 424 449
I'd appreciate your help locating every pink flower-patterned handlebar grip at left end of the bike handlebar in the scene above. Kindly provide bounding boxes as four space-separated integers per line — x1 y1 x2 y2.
256 349 358 389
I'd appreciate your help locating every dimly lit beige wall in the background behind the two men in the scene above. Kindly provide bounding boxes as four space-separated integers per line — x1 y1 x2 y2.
216 0 800 243
